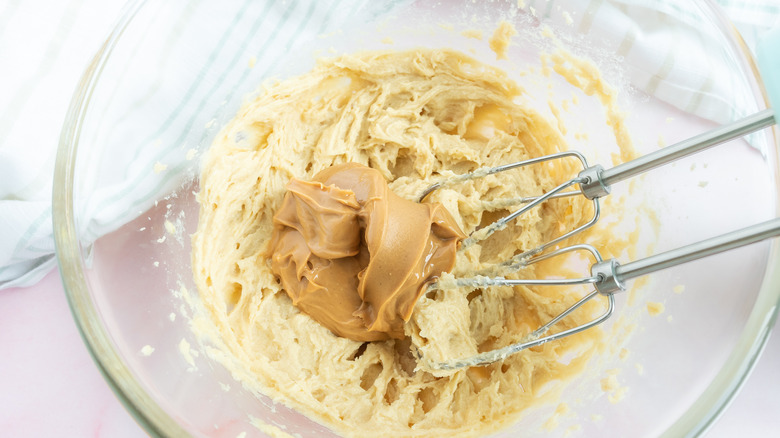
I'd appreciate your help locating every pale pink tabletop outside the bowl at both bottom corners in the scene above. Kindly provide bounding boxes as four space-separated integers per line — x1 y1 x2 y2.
0 271 780 438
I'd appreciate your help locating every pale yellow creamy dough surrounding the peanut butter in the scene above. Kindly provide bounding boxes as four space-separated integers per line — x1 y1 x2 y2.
193 49 636 437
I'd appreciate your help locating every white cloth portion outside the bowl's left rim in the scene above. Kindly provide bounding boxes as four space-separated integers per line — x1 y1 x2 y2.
0 0 124 288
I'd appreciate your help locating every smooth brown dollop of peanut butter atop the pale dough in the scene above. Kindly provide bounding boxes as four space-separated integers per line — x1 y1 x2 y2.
271 163 465 341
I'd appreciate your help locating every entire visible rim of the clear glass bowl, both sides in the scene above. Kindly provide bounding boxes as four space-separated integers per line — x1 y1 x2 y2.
52 0 780 437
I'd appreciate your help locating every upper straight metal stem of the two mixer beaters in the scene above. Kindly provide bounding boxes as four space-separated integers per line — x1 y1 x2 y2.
600 109 775 186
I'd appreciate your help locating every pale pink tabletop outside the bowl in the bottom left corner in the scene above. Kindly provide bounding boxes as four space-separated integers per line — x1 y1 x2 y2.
0 271 145 438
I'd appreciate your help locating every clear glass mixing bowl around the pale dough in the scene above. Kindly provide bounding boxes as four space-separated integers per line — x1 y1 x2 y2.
53 0 780 437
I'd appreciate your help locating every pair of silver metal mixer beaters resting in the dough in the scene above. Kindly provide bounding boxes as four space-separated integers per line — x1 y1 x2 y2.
420 109 780 370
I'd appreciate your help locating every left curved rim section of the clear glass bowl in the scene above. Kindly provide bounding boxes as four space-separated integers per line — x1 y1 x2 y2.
52 0 189 437
